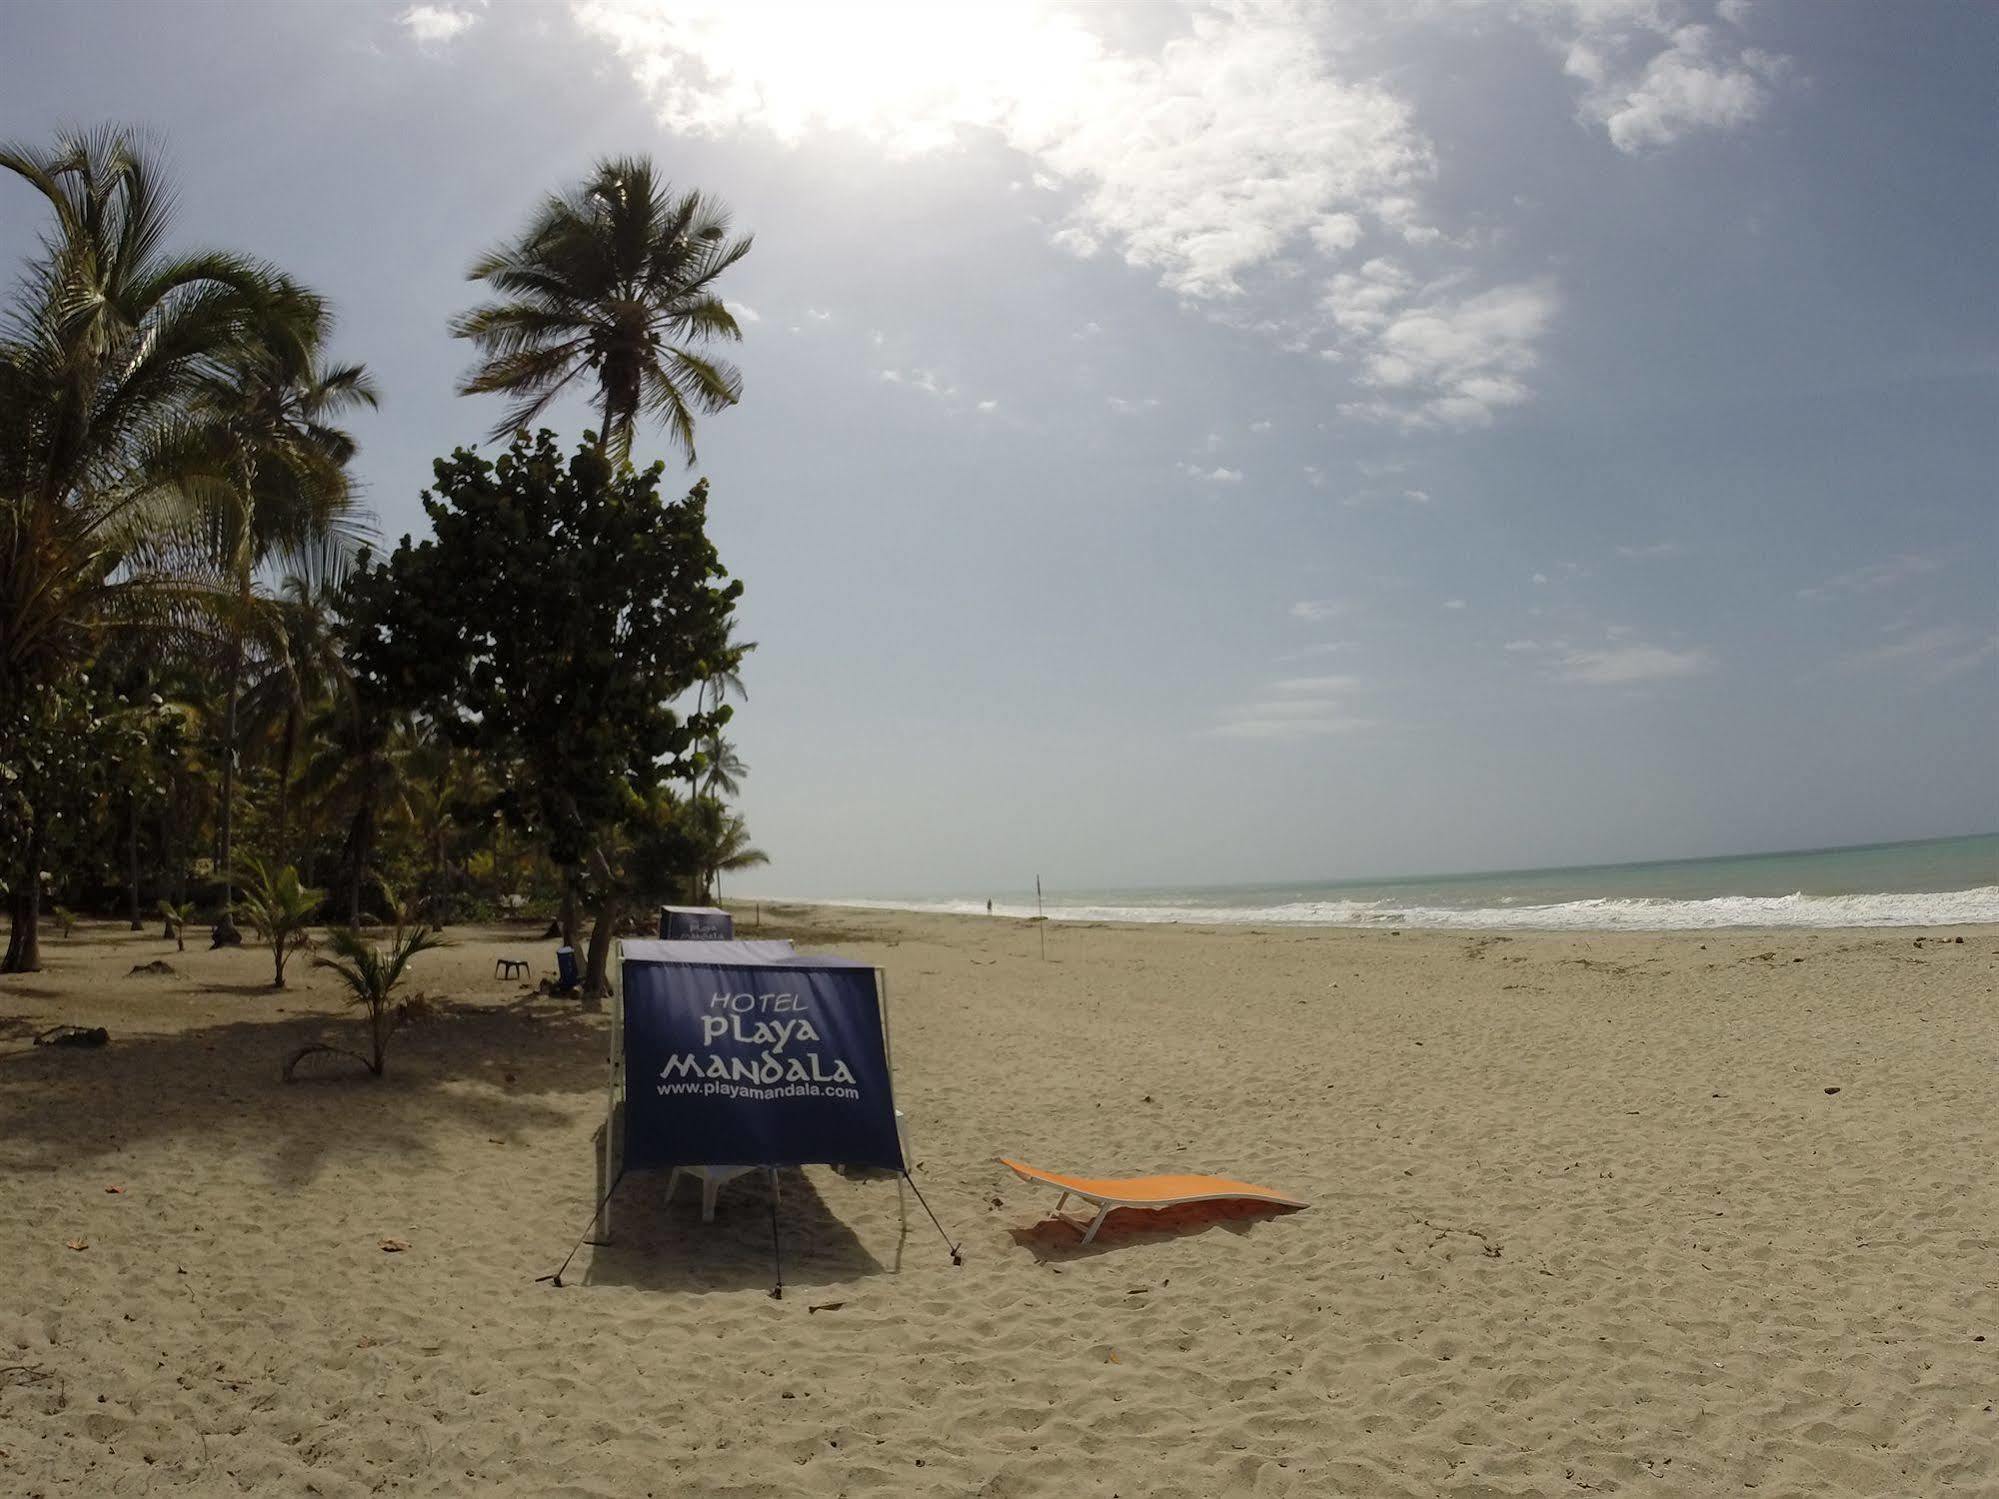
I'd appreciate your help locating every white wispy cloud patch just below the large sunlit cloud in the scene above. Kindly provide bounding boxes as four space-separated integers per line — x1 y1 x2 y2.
1319 260 1557 428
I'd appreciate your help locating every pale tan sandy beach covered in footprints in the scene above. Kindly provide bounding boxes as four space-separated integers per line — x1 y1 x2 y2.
0 907 1999 1499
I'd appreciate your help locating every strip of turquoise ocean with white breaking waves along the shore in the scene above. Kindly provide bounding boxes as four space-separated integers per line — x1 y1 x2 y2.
834 833 1999 931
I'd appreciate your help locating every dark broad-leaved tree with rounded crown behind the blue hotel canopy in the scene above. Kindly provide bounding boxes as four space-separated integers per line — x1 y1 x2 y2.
348 432 742 993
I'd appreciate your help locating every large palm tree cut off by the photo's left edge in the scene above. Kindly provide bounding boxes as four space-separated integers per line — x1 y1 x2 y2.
0 130 287 971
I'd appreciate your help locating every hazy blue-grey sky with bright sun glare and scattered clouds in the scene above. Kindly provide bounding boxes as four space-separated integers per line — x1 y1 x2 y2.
0 0 1999 895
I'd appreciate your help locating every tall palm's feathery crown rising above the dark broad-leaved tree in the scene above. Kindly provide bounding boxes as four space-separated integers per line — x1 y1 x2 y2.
452 156 750 464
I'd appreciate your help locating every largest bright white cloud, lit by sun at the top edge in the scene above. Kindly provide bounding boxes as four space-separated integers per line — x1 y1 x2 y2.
572 0 1433 300
